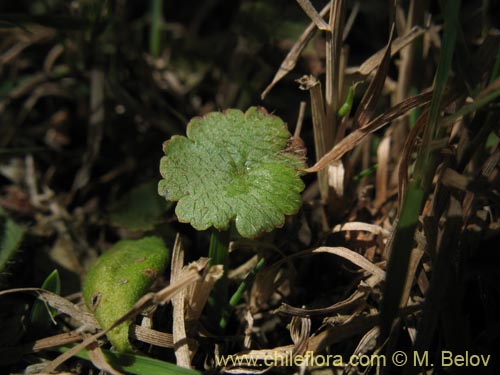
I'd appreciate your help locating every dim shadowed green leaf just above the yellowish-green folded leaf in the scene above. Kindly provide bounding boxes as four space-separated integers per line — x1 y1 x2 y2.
110 181 168 232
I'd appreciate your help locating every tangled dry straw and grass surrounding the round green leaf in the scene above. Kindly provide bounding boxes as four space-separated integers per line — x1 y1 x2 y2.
0 0 500 374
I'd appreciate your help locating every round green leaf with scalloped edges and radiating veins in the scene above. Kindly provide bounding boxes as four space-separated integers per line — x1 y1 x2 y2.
158 107 305 238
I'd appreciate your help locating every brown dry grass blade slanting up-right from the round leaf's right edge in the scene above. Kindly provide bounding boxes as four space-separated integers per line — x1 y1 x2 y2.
304 92 432 173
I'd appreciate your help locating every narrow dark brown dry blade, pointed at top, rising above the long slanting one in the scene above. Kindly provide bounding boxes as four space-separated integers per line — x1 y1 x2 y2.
354 23 395 128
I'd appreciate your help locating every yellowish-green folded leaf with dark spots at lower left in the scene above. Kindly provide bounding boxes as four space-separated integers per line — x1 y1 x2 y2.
82 237 168 351
